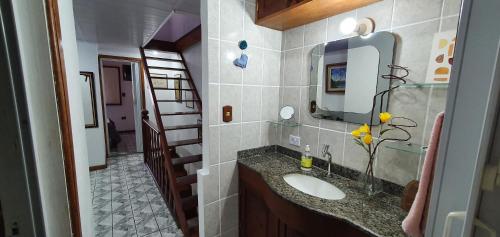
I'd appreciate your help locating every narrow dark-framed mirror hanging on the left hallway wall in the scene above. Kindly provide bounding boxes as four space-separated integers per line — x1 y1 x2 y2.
79 72 97 128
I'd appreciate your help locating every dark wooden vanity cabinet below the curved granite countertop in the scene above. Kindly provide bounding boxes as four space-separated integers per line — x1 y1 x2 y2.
238 164 370 237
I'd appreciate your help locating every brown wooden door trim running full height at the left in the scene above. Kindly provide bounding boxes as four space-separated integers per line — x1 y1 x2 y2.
45 0 82 237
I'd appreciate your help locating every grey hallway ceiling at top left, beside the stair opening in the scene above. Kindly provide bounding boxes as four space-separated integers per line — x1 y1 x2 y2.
73 0 200 46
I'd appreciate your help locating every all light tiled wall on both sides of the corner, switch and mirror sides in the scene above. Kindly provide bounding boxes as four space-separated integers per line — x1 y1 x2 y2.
201 0 460 237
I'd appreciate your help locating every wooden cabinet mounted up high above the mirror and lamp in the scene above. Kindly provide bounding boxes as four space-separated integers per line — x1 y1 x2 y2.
255 0 380 30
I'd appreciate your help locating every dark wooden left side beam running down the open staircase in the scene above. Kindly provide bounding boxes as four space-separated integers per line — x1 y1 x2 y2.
140 47 189 234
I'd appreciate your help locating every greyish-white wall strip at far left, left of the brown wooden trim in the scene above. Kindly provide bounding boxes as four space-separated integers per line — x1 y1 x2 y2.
12 0 71 237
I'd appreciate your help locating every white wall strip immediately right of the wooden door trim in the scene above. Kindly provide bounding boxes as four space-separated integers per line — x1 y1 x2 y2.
58 0 94 236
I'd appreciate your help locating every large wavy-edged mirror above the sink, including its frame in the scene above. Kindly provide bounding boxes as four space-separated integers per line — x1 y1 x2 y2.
309 32 395 124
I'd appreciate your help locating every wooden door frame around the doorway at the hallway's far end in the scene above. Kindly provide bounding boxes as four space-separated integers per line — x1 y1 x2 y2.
97 54 146 158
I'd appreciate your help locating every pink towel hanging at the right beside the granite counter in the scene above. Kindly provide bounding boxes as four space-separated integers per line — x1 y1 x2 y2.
402 112 444 237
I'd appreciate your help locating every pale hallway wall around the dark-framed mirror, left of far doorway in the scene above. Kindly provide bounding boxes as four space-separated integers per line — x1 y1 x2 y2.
77 41 106 166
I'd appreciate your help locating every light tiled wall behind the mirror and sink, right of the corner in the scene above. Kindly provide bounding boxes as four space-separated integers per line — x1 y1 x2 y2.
279 0 460 185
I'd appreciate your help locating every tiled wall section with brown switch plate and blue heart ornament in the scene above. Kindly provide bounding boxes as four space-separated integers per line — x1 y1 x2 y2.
203 0 283 237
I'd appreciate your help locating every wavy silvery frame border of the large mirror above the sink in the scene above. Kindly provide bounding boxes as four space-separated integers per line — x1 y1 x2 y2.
309 31 396 125
